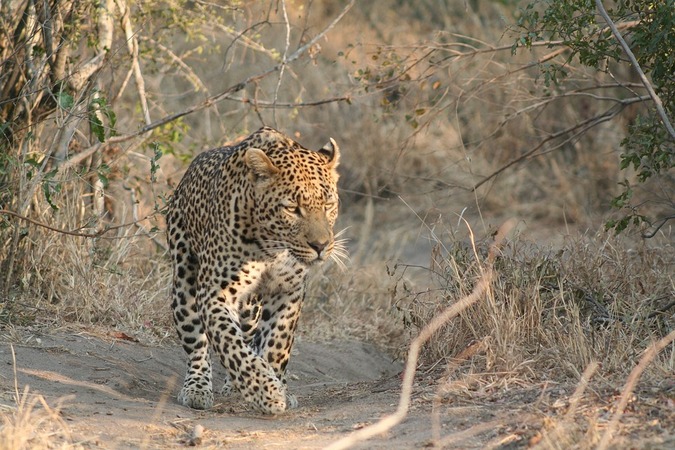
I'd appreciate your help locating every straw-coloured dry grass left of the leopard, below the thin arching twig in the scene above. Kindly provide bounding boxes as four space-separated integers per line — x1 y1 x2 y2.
4 216 173 342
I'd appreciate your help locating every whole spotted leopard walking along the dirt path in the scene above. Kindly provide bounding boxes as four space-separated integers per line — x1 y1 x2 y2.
166 127 346 414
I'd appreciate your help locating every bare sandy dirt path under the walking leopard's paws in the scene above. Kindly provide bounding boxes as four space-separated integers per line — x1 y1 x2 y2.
0 326 438 449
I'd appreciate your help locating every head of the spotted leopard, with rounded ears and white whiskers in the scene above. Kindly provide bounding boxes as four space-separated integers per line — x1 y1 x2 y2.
244 138 344 265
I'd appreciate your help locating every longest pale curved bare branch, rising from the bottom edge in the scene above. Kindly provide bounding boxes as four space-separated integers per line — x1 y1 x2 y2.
326 219 515 450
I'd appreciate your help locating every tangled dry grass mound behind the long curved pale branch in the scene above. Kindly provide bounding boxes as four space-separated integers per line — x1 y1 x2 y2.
399 220 675 382
